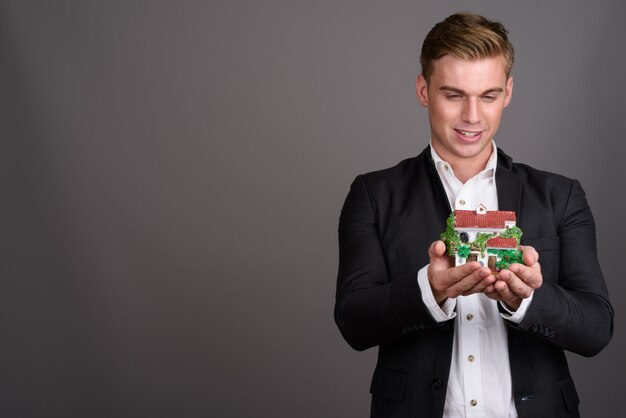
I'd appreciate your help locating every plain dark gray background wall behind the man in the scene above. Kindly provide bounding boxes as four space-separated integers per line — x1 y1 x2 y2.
0 0 626 418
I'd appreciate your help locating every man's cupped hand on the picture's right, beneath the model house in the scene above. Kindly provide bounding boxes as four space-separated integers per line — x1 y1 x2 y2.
484 245 543 311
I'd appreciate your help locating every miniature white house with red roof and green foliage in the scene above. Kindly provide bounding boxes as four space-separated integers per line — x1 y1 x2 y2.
442 205 522 271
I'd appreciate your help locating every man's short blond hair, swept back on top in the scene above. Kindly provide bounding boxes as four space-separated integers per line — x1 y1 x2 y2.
420 12 515 81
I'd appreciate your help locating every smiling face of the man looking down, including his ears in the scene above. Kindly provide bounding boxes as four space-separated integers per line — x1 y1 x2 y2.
417 55 513 169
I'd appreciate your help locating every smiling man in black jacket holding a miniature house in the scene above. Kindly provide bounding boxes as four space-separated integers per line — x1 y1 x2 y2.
335 13 613 418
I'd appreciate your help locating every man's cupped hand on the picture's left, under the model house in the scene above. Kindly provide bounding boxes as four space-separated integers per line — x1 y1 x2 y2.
428 241 496 305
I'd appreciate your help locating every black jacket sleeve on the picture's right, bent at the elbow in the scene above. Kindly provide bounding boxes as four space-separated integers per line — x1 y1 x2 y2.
519 180 613 356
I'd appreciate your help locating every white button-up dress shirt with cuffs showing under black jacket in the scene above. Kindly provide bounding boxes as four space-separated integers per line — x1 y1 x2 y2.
417 142 532 418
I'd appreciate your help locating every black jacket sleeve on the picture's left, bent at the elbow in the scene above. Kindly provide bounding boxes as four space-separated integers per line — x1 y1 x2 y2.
335 176 439 350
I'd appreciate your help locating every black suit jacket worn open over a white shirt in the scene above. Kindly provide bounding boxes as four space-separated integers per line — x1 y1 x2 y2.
335 148 613 418
